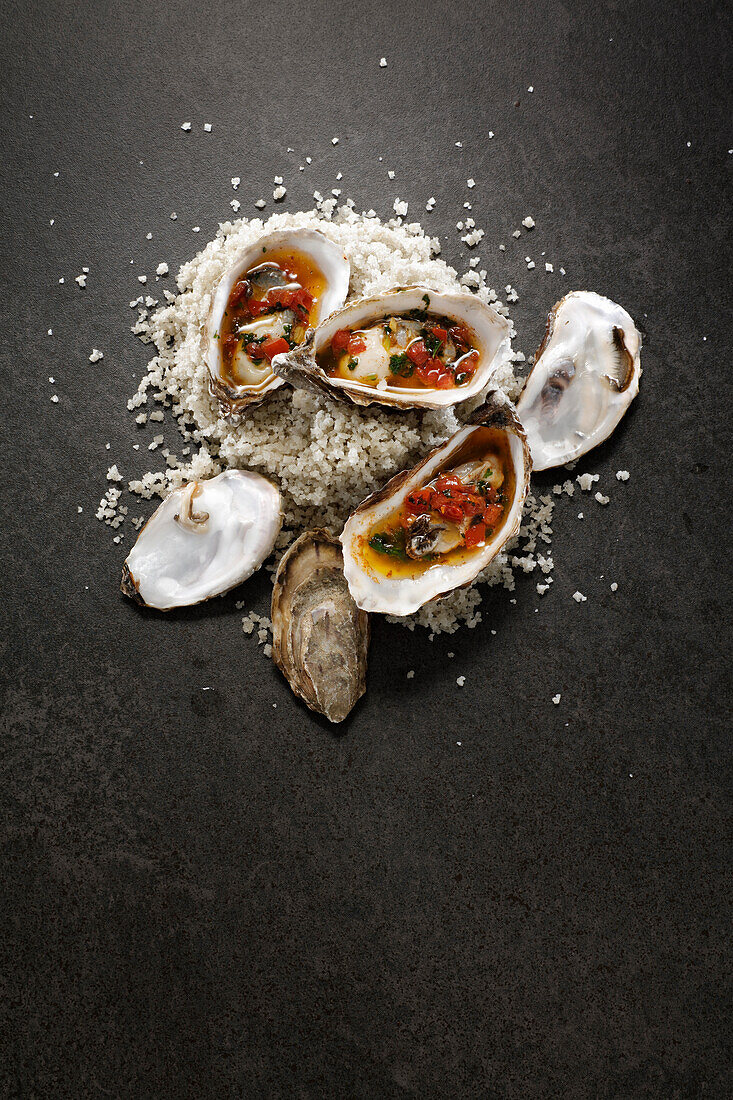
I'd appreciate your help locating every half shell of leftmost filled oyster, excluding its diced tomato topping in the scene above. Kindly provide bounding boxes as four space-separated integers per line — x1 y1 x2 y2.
203 229 350 417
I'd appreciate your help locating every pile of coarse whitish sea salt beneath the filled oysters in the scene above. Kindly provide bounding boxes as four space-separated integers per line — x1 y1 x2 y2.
121 200 554 640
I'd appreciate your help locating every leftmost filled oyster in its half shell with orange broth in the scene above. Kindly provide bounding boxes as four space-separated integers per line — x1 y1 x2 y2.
203 229 350 417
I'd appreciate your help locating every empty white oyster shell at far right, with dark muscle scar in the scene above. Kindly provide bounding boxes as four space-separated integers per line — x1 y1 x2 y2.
516 290 642 470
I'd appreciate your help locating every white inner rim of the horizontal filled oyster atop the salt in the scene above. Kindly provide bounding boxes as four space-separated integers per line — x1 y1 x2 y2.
294 286 512 408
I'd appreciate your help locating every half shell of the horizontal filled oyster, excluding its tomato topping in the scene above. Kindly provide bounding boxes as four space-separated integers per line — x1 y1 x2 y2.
272 286 512 408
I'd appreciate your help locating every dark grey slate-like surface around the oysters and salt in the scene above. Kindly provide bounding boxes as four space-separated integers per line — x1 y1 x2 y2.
0 0 733 1098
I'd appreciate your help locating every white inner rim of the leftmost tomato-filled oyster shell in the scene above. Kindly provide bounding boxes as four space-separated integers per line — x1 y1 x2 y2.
205 229 351 400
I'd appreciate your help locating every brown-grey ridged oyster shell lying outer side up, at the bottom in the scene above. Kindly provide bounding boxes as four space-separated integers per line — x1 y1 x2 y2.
272 530 369 723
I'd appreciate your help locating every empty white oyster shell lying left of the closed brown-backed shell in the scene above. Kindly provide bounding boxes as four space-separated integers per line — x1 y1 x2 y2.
121 470 283 612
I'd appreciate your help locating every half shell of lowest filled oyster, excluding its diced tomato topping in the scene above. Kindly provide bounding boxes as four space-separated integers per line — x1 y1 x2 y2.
341 392 532 615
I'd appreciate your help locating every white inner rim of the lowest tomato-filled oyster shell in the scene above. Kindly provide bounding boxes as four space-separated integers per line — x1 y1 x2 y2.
341 413 528 615
